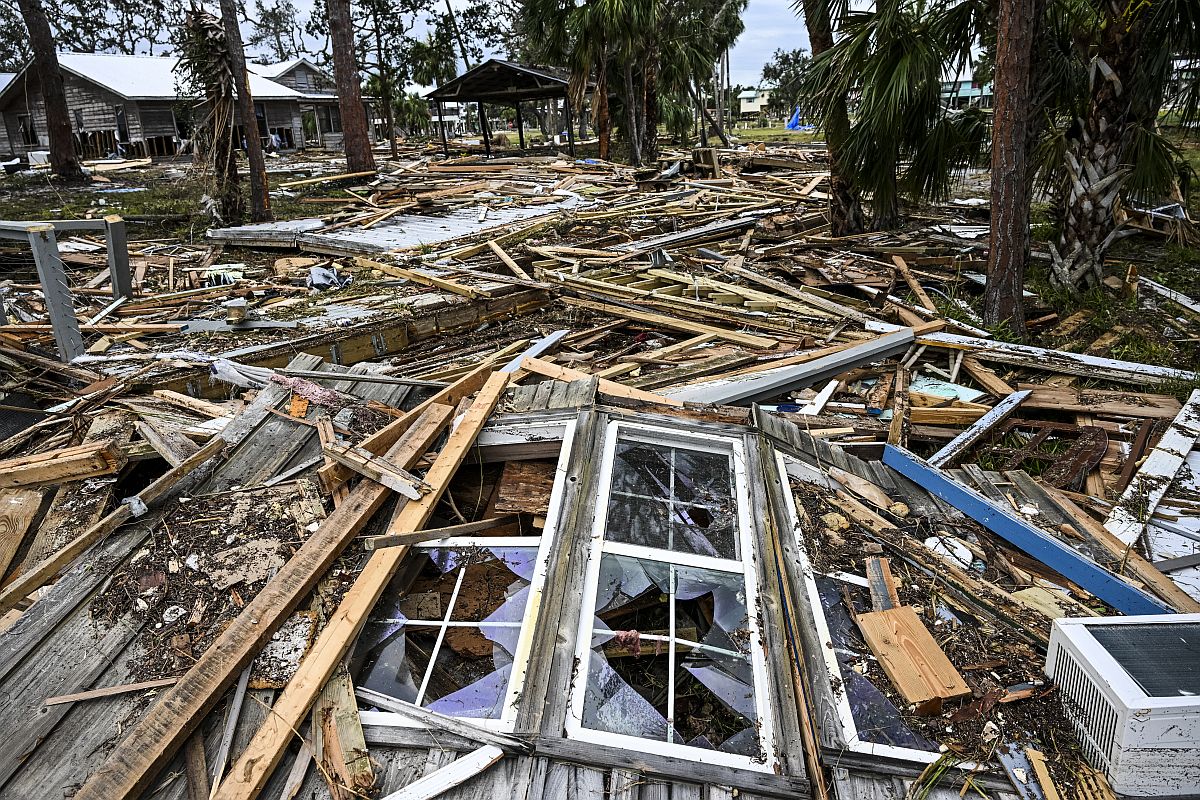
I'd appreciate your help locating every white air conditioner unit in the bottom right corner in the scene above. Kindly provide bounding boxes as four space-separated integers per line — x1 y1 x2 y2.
1046 614 1200 798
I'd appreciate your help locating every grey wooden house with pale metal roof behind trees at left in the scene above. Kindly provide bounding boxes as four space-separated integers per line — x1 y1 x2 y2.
0 53 319 158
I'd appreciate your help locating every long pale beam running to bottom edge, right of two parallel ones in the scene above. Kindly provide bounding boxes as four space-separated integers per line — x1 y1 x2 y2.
205 372 510 800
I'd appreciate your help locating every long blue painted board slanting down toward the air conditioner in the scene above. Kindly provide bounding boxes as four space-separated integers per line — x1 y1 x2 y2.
883 445 1175 615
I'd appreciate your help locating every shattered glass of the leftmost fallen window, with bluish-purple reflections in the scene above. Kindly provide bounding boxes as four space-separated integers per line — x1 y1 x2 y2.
355 547 538 720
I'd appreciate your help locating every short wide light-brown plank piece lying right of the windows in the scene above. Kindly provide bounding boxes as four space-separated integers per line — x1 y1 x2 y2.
856 606 971 705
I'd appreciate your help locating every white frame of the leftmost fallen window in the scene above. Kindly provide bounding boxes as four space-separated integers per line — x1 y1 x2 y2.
359 420 576 733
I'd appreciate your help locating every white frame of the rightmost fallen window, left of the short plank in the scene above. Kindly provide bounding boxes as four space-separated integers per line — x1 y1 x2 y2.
775 450 976 770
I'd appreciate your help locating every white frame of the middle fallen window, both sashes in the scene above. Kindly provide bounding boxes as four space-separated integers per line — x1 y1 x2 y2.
565 420 779 774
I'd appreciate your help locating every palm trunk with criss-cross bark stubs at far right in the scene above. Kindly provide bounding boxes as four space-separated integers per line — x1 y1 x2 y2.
1050 16 1141 289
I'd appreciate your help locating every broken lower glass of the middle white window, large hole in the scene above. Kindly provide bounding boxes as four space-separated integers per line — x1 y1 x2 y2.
583 554 761 757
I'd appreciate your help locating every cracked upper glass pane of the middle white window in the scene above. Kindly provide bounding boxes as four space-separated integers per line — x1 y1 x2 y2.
605 439 738 559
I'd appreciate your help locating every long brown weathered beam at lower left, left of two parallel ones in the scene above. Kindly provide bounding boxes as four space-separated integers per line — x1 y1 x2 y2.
76 405 454 800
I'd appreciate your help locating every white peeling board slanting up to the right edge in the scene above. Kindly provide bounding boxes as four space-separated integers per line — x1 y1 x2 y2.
1104 389 1200 545
